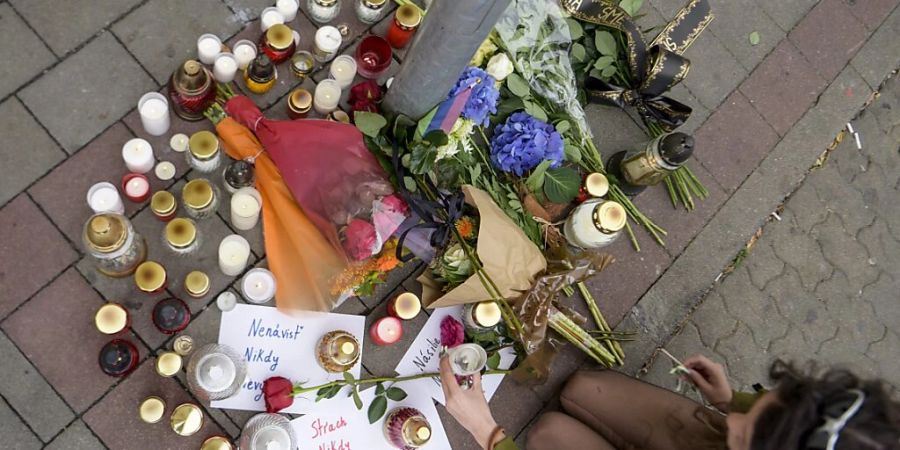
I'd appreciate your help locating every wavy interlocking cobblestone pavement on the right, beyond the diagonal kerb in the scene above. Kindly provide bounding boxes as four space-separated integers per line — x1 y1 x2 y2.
647 73 900 389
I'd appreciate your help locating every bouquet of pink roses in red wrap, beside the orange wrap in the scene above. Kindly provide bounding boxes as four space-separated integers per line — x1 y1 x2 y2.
225 94 406 268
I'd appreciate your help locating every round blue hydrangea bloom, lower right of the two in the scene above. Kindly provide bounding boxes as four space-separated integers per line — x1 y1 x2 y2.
491 111 565 177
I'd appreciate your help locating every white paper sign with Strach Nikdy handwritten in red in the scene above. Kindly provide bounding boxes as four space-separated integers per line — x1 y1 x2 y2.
291 382 452 450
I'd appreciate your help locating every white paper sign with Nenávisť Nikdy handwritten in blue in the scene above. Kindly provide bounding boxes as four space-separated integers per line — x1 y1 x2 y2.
212 304 366 414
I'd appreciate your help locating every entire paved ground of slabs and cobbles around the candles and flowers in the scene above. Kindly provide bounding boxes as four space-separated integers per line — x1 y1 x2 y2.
0 0 900 449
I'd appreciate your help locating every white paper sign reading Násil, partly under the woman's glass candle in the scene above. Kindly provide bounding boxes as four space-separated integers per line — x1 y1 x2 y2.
394 306 516 405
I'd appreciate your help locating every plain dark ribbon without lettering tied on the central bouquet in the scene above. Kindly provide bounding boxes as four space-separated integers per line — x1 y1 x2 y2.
391 142 466 262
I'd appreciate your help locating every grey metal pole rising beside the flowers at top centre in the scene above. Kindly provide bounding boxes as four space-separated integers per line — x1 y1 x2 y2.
382 0 510 120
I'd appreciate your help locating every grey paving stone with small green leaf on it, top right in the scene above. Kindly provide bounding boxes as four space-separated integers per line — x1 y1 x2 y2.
709 0 785 71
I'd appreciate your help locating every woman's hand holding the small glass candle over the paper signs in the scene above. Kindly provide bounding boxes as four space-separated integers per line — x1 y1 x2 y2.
441 356 502 449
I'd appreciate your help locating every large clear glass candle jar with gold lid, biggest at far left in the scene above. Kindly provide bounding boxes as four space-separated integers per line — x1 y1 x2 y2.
82 213 147 278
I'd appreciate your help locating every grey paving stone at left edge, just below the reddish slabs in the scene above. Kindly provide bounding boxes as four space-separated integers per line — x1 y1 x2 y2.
0 333 75 441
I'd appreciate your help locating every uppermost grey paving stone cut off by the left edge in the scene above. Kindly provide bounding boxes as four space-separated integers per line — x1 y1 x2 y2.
0 4 56 98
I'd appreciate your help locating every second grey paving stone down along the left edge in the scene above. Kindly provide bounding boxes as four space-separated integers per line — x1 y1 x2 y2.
0 97 65 205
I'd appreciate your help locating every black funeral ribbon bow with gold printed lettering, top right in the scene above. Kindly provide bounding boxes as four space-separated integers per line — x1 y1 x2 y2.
560 0 713 131
